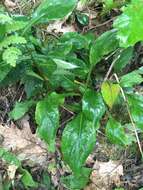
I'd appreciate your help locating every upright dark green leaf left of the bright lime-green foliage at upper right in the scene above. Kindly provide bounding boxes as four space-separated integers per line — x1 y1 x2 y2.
90 30 118 65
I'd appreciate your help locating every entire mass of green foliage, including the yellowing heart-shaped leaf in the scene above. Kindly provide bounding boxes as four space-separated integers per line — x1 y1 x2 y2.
0 0 143 189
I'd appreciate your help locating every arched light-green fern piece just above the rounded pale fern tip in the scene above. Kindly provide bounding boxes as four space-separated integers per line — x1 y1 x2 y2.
0 35 26 50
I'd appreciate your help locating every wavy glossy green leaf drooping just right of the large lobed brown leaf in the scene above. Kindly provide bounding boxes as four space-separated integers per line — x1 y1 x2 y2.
35 92 64 152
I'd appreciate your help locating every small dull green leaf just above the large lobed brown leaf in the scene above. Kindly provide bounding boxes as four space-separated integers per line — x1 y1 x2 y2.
9 100 35 120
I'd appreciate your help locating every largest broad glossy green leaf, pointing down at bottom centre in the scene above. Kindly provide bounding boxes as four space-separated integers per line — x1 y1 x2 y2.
61 113 96 176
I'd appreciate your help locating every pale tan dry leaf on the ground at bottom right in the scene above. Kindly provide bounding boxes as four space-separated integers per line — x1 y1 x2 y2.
85 160 123 190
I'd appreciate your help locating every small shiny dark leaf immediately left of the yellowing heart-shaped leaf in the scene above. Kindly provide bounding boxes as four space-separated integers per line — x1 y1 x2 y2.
82 90 105 126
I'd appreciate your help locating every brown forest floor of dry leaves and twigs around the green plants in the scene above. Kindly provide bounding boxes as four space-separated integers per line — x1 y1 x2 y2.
0 0 143 190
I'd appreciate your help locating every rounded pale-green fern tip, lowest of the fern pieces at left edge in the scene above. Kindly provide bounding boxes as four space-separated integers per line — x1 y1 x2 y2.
2 47 22 67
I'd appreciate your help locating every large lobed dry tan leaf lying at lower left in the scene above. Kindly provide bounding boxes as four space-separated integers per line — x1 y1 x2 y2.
0 116 47 166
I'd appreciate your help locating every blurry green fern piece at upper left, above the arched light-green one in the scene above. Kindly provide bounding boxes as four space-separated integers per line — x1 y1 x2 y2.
6 21 27 33
